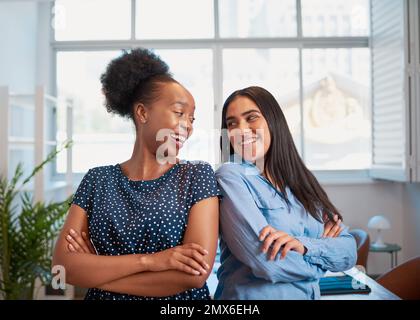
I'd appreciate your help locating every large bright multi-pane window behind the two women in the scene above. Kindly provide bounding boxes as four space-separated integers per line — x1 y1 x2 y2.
51 0 371 172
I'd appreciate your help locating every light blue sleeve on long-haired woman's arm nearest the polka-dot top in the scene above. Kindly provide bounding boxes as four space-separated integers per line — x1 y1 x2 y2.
216 170 325 283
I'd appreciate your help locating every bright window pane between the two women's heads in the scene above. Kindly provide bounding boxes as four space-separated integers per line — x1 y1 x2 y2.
156 49 220 164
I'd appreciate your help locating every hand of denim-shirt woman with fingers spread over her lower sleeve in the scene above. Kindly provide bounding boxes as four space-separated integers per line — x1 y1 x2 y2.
259 225 306 260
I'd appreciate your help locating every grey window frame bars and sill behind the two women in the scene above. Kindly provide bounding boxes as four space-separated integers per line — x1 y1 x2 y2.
50 0 373 184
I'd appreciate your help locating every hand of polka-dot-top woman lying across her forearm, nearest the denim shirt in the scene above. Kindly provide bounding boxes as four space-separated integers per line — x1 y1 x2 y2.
146 243 210 275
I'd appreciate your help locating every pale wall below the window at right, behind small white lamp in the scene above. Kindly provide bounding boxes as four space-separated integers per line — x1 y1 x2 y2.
324 181 420 274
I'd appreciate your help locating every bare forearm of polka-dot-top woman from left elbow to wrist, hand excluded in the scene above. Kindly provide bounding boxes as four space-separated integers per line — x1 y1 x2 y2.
53 253 146 288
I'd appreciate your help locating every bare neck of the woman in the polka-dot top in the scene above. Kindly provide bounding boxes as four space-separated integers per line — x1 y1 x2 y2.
121 135 173 180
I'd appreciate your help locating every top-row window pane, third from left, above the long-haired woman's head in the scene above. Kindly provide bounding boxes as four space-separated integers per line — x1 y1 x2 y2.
219 0 297 38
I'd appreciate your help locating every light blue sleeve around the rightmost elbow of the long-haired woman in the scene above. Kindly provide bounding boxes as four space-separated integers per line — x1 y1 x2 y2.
295 227 357 272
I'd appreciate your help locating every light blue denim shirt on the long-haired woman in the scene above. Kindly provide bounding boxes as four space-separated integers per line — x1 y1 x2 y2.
214 162 357 300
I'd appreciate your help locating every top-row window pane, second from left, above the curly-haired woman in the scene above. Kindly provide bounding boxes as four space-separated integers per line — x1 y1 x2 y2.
136 0 214 39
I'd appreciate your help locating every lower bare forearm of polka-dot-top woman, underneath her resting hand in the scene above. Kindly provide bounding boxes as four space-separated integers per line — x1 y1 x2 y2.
98 270 207 297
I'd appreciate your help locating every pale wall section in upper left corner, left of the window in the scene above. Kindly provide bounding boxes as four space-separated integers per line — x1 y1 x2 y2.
0 0 54 94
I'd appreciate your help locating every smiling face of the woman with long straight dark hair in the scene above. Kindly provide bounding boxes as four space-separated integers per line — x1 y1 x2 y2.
226 96 271 162
